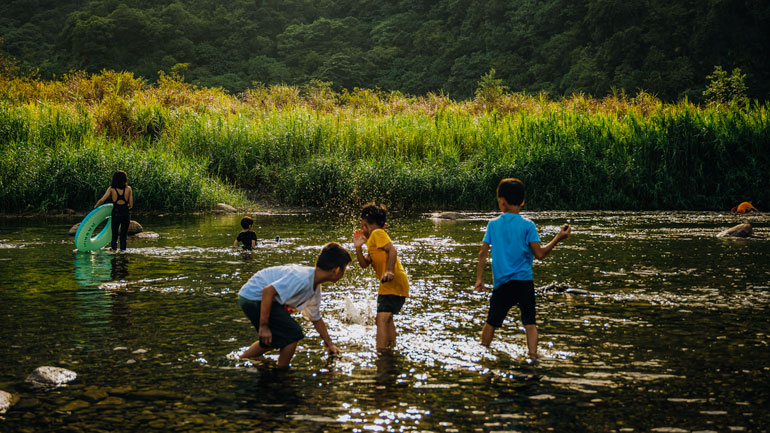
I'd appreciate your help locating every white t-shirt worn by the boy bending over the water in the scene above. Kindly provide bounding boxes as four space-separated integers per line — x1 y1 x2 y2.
238 265 321 322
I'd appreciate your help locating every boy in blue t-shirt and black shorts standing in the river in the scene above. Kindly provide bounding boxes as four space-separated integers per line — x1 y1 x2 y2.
476 178 572 361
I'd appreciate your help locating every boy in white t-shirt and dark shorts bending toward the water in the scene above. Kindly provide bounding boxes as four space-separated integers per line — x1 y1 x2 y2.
238 242 351 368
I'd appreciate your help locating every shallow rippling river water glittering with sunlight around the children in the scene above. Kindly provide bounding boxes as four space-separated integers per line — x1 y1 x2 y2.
0 212 770 432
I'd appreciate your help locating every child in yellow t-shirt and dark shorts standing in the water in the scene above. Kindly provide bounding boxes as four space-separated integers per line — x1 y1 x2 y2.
353 203 409 351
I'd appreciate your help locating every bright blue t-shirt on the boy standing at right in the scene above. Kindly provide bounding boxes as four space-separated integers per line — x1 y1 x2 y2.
484 213 540 289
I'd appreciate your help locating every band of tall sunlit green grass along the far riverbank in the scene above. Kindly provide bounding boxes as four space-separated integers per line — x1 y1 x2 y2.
0 71 770 212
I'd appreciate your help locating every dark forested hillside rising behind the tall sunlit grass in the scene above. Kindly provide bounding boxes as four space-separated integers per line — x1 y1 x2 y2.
0 0 770 101
